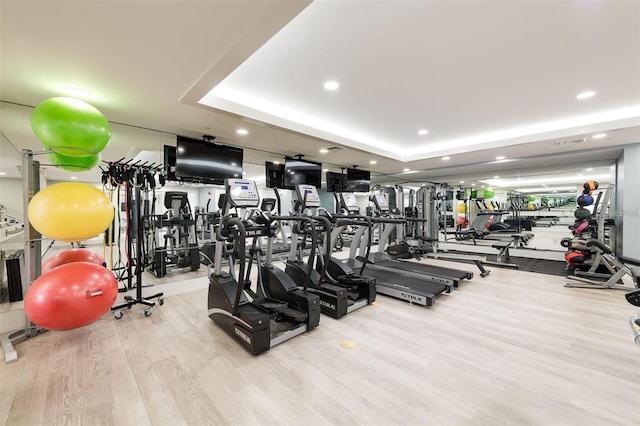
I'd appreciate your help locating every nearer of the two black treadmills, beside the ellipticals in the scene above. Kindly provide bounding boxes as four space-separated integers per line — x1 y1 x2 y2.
339 192 451 306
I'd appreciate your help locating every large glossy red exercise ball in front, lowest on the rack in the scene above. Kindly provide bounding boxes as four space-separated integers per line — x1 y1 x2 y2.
24 262 118 330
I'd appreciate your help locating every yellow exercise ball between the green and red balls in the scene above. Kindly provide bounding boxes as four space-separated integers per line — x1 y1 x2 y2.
27 182 114 242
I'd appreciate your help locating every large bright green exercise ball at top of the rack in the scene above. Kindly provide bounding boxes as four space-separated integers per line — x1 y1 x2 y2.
31 97 111 157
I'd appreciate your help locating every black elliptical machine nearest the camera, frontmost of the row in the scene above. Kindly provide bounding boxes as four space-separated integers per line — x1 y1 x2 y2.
208 179 320 355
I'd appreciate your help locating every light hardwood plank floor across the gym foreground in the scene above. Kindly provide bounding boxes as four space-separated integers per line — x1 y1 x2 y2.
0 261 640 426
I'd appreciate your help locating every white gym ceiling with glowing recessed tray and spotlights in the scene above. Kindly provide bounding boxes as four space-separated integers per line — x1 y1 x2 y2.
0 0 640 193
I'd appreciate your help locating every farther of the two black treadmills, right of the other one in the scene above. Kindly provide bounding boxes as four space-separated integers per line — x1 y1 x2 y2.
358 194 473 288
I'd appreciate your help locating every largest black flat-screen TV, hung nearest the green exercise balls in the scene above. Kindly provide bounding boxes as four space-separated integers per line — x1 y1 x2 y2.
176 136 243 184
